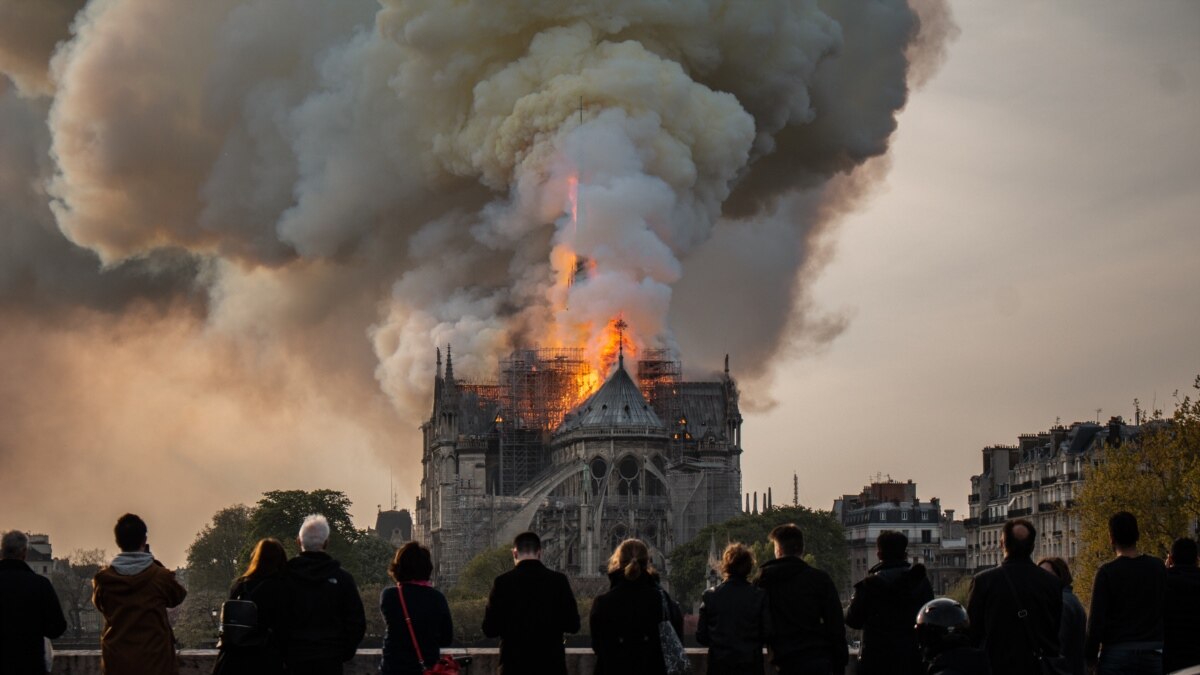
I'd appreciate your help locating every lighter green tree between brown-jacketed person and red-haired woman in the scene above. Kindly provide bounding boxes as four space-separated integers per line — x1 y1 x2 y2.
187 504 253 593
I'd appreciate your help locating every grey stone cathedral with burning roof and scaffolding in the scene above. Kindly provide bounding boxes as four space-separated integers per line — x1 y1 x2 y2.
415 348 742 585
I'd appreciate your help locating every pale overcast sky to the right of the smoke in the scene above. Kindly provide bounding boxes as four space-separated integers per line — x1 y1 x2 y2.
743 1 1200 513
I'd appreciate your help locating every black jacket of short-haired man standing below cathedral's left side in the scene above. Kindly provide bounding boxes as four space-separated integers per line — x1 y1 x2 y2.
484 560 580 675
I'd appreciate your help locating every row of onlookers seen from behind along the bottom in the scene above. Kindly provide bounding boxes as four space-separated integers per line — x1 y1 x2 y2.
0 512 1200 675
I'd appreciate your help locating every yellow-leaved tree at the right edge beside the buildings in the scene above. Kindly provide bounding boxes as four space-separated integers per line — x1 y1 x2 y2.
1074 376 1200 603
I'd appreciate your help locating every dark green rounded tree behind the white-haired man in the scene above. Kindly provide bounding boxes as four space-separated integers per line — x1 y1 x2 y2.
243 490 362 560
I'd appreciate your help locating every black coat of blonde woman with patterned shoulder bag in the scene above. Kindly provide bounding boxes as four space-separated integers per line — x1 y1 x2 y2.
588 571 683 675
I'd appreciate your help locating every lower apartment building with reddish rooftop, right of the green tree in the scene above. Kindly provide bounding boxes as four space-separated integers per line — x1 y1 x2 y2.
833 479 966 599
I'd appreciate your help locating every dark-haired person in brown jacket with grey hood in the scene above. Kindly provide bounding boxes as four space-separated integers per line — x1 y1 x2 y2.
91 513 187 675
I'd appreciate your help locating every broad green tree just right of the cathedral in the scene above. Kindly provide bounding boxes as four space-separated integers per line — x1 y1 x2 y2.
670 507 850 607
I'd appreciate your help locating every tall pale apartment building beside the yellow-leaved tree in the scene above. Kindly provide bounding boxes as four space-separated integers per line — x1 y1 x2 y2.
964 417 1139 571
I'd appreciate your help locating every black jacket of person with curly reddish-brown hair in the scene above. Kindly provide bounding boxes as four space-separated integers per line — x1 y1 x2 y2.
696 577 770 675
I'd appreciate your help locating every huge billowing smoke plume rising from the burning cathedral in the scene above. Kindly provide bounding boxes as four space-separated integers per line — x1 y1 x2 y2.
0 0 954 557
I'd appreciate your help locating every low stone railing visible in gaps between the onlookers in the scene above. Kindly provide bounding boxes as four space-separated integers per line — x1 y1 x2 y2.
54 647 774 675
